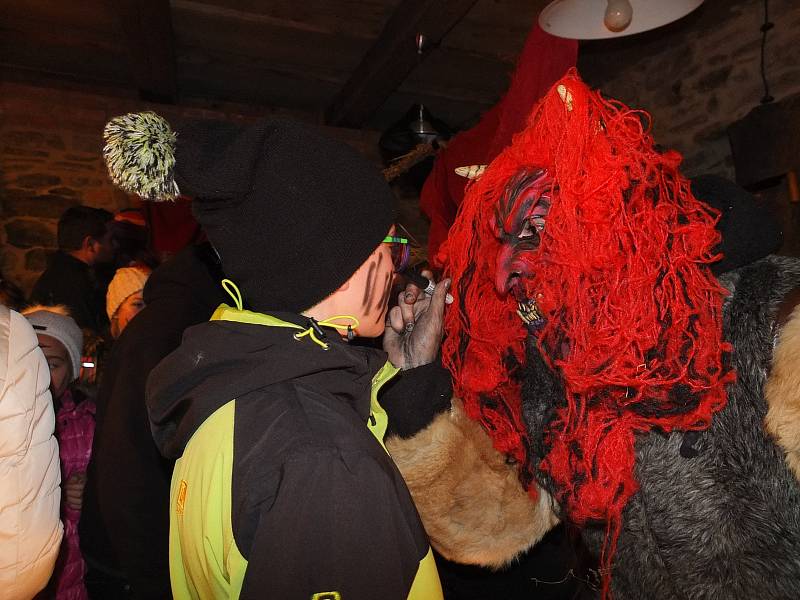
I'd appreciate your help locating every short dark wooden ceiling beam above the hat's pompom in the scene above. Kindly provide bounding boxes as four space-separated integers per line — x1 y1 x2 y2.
111 0 178 104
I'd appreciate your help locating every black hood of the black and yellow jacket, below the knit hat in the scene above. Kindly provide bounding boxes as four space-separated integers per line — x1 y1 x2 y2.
147 304 386 459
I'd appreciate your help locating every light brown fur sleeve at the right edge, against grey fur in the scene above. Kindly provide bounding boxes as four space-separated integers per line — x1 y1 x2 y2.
765 306 800 480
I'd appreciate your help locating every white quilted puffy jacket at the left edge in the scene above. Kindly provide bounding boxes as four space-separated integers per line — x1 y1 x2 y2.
0 304 63 600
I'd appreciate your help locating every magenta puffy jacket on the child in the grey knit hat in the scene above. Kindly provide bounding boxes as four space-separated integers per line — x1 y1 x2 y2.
55 390 95 600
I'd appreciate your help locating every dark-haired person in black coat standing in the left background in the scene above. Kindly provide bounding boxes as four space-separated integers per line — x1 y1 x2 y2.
31 206 114 335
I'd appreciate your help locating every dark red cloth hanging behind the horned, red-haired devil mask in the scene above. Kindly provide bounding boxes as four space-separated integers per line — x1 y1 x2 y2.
420 23 578 268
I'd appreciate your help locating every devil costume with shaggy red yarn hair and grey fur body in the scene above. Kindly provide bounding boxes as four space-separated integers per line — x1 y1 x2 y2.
432 73 800 600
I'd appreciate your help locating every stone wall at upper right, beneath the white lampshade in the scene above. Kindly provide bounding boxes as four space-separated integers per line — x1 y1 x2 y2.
579 0 800 178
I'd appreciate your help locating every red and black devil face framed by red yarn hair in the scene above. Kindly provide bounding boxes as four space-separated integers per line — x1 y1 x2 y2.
495 168 554 301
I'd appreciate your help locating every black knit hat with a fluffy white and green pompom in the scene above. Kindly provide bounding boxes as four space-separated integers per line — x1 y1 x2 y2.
104 113 393 312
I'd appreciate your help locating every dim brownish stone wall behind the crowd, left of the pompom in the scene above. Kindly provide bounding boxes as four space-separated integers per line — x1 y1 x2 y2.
0 82 380 294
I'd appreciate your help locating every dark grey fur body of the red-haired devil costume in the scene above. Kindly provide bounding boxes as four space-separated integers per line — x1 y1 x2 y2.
523 257 800 600
